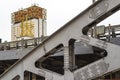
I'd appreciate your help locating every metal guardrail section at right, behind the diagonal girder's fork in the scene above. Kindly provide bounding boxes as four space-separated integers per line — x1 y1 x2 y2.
88 24 120 38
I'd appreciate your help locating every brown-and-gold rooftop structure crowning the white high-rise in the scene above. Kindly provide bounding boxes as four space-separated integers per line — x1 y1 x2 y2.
12 5 46 24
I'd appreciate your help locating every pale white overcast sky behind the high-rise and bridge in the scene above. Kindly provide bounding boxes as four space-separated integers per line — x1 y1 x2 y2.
0 0 120 42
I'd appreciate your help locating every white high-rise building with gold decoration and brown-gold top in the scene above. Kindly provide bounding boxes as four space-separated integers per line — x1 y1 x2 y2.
11 5 46 41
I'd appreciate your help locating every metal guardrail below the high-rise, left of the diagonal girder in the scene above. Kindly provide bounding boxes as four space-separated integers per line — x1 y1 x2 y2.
0 37 47 51
